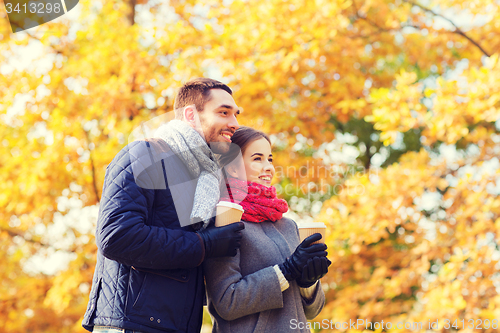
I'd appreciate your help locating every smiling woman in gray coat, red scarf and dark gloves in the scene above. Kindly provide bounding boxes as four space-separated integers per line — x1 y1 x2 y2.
204 127 330 333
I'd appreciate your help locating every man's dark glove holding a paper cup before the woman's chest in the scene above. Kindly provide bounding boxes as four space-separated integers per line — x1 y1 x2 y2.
198 222 245 258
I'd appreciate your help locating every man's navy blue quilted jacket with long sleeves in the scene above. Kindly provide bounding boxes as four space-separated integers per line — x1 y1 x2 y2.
83 139 205 333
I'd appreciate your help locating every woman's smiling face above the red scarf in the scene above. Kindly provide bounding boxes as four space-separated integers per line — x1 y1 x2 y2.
228 138 274 186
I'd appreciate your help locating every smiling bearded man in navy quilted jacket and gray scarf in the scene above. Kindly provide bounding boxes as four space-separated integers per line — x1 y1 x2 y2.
83 78 244 333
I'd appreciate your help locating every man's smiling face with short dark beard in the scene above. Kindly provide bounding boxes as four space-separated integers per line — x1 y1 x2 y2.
198 89 240 154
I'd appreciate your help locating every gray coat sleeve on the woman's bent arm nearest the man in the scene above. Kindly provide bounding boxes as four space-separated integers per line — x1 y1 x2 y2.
204 251 283 321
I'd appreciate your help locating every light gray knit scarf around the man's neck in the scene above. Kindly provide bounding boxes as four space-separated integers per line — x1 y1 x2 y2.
154 119 221 227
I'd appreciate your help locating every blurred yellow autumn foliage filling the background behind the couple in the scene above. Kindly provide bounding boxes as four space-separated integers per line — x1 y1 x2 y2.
0 0 500 333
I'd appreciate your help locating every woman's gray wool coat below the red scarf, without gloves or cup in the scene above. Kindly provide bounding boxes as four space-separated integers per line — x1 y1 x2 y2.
204 218 325 333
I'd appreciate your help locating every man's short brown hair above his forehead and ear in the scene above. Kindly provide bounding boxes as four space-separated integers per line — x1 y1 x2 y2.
174 77 233 120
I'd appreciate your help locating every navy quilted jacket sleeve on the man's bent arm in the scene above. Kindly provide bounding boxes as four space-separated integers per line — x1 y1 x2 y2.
96 142 204 269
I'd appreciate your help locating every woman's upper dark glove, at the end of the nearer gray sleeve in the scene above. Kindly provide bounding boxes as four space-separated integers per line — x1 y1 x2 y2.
278 233 328 281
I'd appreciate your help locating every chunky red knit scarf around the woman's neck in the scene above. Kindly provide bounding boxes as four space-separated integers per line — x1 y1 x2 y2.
221 178 288 222
